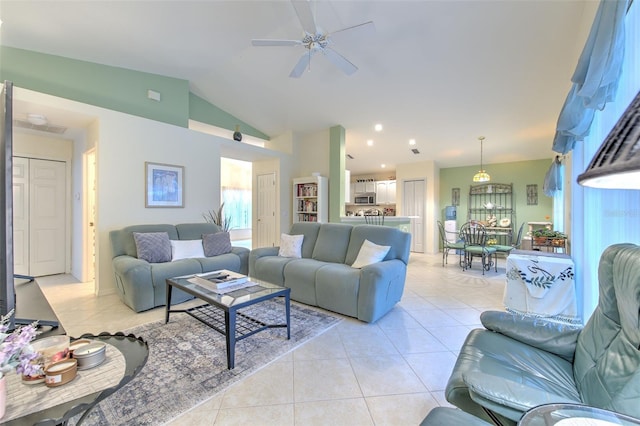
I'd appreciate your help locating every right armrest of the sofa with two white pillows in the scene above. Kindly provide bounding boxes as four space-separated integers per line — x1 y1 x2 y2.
358 259 407 322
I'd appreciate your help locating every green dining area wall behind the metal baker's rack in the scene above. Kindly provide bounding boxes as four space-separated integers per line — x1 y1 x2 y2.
439 159 553 231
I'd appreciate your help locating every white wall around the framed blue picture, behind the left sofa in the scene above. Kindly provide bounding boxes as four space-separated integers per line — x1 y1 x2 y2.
14 88 291 295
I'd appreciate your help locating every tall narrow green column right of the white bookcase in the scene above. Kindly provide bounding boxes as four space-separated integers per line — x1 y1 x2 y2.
329 126 346 223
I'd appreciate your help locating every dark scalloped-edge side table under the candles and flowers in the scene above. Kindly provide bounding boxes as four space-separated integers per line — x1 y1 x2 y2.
0 332 149 426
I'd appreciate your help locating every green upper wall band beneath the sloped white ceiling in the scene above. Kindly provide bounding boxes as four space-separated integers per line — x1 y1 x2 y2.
0 46 269 140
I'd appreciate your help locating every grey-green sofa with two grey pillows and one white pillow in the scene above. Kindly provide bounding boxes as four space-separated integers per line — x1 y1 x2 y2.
109 223 249 312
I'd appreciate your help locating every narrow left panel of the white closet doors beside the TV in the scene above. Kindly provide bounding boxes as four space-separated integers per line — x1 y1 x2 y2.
13 157 29 275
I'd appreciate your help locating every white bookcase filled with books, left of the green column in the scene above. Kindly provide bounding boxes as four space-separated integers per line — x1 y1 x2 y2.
293 176 329 223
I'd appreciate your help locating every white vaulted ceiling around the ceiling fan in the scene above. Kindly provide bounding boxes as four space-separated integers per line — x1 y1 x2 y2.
0 0 597 174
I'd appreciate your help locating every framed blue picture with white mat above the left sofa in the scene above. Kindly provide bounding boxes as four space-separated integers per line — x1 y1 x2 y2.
144 162 184 207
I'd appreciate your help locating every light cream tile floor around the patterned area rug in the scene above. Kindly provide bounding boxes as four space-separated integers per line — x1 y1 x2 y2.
38 253 505 426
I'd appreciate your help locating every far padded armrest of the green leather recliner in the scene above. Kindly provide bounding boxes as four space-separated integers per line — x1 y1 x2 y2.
480 311 582 361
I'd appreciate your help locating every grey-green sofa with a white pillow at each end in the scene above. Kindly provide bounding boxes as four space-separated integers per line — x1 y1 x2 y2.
249 222 411 322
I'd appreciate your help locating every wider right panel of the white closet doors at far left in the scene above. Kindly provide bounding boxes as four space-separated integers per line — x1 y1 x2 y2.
29 159 67 277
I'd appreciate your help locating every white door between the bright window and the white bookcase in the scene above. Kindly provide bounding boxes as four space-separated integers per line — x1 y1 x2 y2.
253 173 276 247
